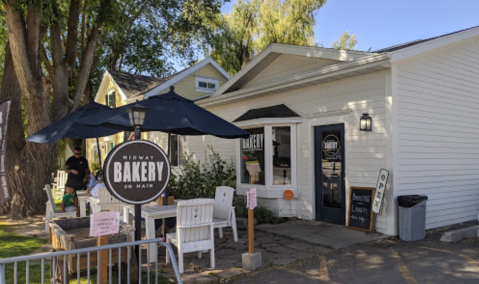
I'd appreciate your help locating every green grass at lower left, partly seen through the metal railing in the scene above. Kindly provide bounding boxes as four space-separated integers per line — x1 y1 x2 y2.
0 221 171 284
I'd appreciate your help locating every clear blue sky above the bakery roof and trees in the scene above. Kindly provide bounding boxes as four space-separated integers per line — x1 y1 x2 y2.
222 0 479 51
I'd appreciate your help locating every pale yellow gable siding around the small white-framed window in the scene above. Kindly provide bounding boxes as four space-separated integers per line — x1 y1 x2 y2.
159 64 226 100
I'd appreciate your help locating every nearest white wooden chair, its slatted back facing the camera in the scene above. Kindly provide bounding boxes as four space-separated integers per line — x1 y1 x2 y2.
166 198 215 273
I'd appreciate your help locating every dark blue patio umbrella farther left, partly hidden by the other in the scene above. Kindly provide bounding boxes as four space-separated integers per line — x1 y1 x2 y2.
25 102 125 168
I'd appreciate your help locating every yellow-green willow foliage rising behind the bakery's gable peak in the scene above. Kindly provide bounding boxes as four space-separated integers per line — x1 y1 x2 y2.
203 0 326 75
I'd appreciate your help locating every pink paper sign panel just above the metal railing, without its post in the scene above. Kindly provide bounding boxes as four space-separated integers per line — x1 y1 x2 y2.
90 211 120 237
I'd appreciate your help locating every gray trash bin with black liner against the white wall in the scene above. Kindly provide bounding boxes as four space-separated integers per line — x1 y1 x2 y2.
398 195 427 241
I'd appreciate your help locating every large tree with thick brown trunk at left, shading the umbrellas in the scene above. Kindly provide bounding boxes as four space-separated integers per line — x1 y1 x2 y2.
0 0 222 218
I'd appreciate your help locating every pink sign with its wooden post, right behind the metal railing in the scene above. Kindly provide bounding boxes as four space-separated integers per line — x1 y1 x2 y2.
90 211 120 284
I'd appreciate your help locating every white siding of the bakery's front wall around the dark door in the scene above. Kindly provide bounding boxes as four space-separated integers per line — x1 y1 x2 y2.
188 71 394 232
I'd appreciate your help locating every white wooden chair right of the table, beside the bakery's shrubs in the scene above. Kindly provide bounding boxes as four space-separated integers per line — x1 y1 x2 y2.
213 186 238 243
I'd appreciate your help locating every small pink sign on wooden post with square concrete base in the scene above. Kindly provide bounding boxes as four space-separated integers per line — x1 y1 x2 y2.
242 188 261 270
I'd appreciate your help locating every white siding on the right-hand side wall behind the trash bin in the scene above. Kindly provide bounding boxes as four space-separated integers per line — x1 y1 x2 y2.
395 37 479 229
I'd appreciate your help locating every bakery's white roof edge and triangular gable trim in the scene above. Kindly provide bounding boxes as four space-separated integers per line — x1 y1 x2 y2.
198 26 479 107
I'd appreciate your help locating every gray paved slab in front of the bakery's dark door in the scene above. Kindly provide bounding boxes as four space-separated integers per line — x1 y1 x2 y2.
255 220 389 249
